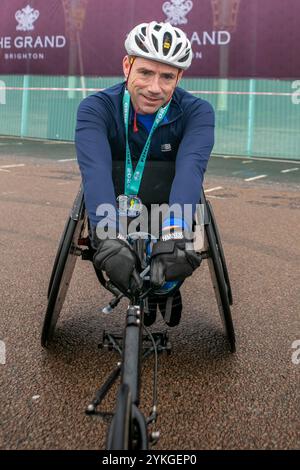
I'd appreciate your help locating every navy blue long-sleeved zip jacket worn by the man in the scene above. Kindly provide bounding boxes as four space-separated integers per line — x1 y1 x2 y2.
75 83 214 226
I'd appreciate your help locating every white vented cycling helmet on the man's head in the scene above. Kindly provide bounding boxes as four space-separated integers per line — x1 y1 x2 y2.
125 21 193 70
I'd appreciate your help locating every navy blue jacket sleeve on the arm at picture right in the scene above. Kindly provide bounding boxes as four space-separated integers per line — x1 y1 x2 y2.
169 100 215 226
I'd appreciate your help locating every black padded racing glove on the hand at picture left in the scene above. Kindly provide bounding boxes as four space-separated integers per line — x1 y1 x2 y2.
92 232 143 294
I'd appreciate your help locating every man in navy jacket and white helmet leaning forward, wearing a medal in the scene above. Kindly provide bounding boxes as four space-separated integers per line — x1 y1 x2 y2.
75 21 214 326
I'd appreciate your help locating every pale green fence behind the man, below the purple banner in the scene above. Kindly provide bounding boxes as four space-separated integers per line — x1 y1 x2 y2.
0 75 300 160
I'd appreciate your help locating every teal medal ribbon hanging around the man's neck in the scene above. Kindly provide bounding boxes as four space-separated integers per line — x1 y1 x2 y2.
123 88 171 196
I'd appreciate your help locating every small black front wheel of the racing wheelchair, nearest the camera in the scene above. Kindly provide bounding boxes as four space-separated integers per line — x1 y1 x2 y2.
106 383 148 450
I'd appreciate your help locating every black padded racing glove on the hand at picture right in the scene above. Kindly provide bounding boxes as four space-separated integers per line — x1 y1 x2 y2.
150 230 202 287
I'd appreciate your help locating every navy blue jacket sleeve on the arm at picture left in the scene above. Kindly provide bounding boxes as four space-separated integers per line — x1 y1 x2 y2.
75 96 116 227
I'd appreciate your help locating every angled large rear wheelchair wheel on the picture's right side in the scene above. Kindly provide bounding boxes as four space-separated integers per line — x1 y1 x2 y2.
205 206 236 352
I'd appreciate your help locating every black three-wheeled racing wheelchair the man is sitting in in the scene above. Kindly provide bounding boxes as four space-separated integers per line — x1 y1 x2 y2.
41 162 235 450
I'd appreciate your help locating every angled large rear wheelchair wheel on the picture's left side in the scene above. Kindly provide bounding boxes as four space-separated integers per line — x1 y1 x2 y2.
41 186 85 347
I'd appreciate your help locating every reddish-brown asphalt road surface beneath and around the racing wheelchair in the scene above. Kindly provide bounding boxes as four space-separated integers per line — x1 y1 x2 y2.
0 139 300 450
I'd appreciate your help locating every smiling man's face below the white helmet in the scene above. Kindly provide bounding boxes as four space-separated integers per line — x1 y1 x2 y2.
123 56 182 114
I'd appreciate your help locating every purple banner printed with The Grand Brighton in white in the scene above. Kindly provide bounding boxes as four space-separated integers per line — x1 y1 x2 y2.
0 0 300 79
